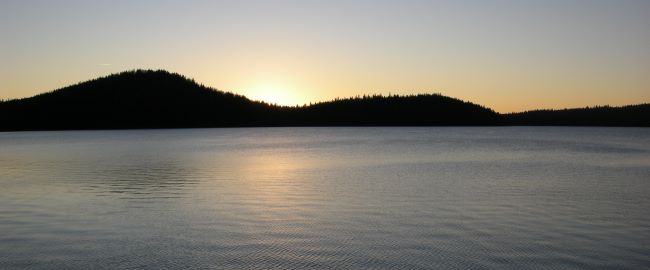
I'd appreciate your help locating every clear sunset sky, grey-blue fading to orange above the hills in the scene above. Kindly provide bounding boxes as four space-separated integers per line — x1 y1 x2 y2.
0 0 650 112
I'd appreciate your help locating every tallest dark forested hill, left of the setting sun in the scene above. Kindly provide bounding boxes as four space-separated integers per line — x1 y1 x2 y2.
0 70 269 130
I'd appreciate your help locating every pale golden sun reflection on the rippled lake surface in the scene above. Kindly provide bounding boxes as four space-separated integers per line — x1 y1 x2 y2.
196 146 318 215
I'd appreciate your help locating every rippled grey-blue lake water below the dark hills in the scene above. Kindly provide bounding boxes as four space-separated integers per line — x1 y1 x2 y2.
0 127 650 269
